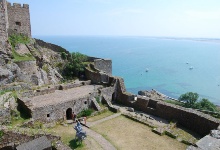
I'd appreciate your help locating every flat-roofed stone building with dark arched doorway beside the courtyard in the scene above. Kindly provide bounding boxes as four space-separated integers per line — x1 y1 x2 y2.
18 85 101 122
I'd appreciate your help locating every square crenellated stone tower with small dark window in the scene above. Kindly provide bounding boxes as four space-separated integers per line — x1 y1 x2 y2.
7 3 31 37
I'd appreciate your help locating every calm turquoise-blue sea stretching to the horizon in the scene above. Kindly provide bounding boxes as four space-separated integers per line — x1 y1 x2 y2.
36 36 220 105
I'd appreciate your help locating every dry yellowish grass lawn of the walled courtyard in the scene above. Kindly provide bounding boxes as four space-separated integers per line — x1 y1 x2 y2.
92 116 187 150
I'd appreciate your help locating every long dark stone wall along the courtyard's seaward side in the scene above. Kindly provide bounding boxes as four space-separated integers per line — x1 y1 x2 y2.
116 90 220 136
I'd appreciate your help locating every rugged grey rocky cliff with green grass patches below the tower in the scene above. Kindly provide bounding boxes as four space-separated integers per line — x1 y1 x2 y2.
0 37 69 87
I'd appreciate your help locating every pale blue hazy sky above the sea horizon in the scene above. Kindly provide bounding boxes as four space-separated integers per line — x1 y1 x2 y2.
9 0 220 38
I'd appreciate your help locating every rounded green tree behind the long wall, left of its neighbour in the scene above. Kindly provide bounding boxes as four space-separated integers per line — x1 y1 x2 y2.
179 92 199 108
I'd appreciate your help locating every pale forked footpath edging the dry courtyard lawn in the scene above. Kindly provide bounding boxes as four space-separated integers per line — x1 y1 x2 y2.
83 113 121 150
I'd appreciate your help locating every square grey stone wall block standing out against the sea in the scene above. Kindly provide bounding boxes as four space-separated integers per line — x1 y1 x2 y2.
94 59 112 75
